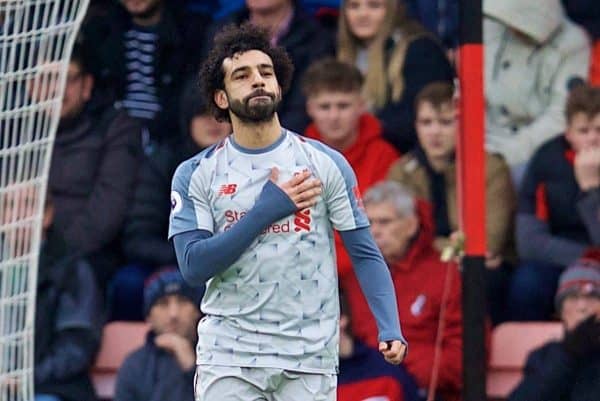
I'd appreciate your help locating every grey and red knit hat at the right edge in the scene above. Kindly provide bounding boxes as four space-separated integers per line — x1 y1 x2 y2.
555 258 600 310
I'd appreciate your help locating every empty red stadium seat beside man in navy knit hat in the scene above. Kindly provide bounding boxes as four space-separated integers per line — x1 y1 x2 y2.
92 322 149 400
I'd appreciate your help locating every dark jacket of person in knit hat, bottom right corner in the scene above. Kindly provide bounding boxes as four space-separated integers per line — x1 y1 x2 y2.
508 342 600 401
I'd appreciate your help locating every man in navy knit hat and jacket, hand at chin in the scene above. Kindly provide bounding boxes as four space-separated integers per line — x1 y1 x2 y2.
115 270 203 401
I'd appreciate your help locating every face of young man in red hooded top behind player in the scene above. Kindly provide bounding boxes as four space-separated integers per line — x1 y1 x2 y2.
307 91 364 150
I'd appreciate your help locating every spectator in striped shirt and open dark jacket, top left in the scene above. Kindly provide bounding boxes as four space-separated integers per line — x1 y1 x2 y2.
82 0 209 151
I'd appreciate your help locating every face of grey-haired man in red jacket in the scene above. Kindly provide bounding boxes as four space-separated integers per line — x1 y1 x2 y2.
365 202 418 264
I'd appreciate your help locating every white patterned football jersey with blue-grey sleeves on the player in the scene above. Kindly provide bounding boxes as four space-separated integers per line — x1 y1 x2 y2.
169 130 368 373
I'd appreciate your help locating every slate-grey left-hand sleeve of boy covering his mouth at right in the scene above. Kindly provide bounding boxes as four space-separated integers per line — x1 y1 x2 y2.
516 213 587 266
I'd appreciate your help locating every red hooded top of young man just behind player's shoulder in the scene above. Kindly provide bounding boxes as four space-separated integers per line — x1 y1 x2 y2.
305 113 399 276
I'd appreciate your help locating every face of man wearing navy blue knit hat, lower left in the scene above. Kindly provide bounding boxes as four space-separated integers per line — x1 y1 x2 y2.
147 295 200 339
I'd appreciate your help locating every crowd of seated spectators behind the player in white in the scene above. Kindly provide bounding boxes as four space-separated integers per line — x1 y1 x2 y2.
0 0 600 401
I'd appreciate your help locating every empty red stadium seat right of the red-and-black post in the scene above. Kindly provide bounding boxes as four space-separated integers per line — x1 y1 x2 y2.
487 322 563 400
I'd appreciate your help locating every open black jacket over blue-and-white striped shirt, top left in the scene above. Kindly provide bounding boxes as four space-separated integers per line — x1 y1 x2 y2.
82 2 210 142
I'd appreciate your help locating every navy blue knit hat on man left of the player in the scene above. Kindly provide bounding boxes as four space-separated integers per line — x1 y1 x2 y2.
144 269 204 316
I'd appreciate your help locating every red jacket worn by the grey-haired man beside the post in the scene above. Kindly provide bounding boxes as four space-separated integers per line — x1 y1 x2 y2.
342 201 462 400
